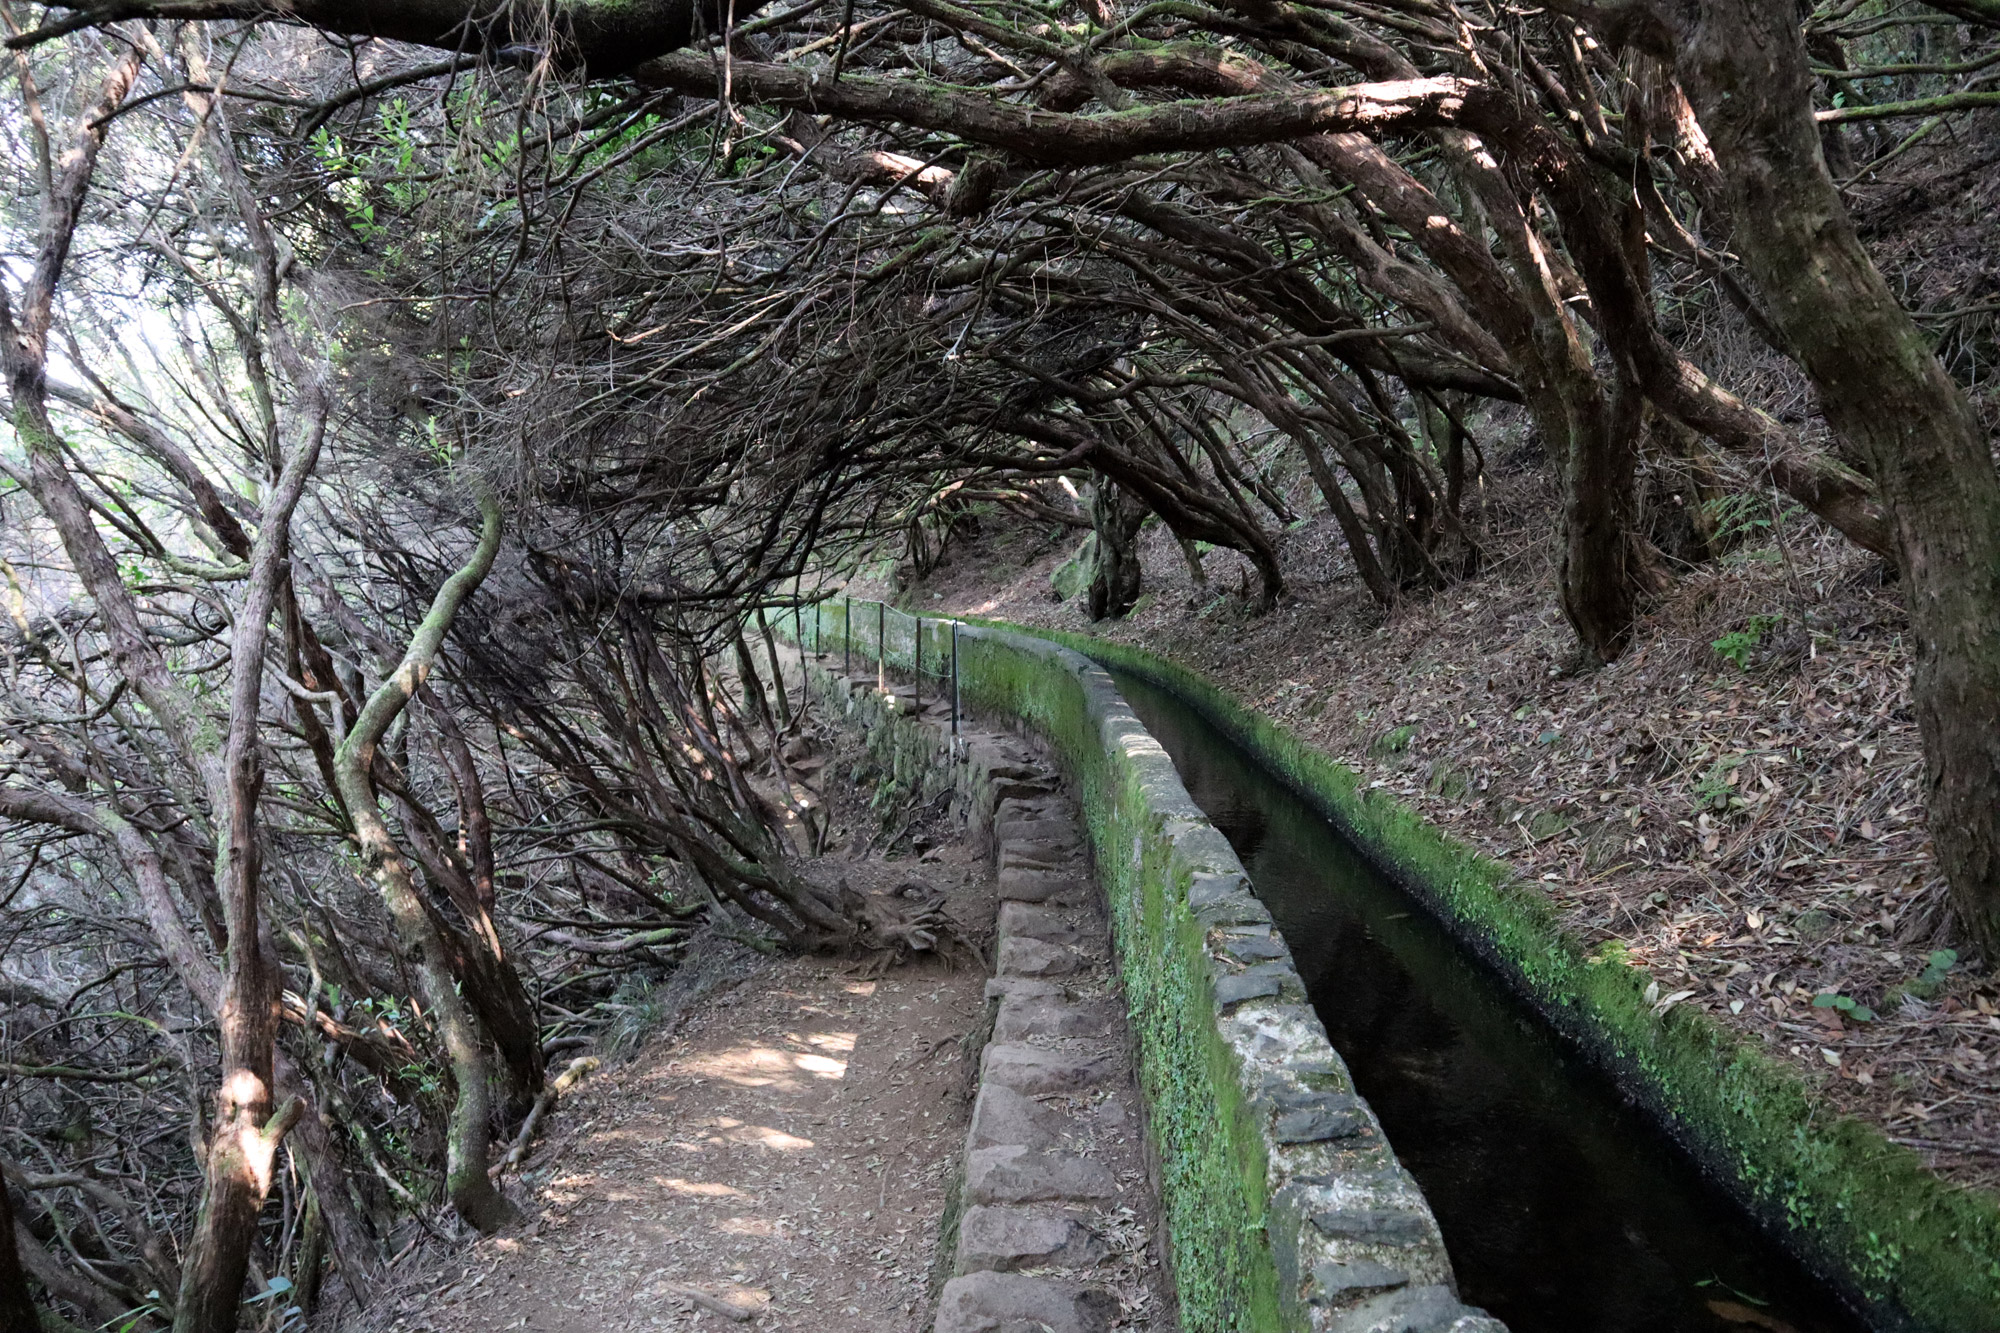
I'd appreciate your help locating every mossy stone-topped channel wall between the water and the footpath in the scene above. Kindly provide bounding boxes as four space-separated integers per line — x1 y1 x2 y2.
798 604 1502 1333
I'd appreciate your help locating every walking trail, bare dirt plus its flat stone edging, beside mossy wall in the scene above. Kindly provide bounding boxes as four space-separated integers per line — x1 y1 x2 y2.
344 673 1176 1333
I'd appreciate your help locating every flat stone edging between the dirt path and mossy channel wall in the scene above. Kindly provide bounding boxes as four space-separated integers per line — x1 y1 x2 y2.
816 673 1172 1333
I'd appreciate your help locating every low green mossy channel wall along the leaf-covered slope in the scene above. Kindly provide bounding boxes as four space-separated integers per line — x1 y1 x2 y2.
1006 632 2000 1333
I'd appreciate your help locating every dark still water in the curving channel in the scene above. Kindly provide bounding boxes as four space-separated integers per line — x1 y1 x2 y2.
1118 673 1868 1333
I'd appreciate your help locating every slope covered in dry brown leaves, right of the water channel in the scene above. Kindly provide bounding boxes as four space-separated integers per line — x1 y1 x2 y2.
896 452 2000 1187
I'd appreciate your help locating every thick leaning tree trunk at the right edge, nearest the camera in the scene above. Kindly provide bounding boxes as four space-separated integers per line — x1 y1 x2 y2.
1660 0 2000 961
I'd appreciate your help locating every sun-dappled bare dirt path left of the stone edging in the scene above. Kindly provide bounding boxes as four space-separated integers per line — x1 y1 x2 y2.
346 772 996 1333
